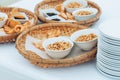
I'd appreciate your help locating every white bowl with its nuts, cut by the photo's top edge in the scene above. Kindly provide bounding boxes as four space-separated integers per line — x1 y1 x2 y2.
63 0 88 13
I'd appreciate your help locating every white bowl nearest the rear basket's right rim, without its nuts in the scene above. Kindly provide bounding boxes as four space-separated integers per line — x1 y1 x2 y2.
72 8 98 21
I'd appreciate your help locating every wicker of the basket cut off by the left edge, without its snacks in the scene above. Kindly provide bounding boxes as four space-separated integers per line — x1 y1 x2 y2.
0 7 38 43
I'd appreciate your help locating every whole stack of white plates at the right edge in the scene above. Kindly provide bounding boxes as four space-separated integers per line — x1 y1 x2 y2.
97 19 120 79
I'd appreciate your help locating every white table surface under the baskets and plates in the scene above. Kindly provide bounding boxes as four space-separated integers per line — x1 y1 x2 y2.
0 0 120 80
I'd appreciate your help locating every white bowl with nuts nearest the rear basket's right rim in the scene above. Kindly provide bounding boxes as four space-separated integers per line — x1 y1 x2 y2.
72 8 98 21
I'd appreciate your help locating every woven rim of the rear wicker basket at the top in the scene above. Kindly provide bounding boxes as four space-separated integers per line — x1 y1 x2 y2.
34 0 102 27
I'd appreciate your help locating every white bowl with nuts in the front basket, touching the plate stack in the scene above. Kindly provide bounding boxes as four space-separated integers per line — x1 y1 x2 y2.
70 29 97 51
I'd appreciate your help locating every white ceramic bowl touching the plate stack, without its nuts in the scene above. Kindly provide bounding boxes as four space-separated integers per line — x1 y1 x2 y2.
70 29 97 51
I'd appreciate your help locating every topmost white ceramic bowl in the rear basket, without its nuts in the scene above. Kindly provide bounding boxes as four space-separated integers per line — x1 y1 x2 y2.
63 0 88 13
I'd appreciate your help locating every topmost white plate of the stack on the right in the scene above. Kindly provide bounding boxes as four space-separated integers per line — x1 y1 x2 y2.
99 19 120 40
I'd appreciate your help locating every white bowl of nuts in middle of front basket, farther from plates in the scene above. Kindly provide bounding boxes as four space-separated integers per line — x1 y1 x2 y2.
43 37 74 59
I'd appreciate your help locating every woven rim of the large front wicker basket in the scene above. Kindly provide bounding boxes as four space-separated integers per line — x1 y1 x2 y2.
16 23 96 66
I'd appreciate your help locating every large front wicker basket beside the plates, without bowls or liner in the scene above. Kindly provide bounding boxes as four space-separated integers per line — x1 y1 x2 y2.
16 23 97 68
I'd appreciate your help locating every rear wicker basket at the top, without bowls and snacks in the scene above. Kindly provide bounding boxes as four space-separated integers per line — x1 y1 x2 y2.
34 0 101 27
